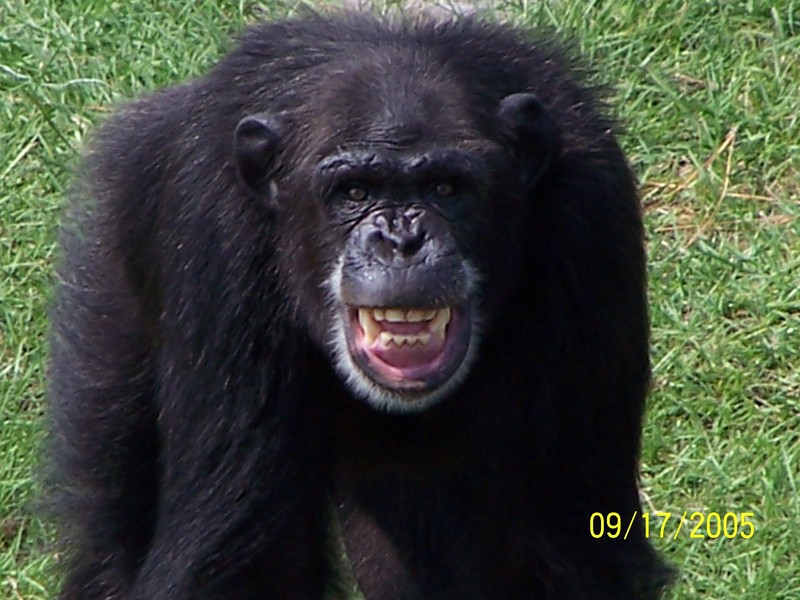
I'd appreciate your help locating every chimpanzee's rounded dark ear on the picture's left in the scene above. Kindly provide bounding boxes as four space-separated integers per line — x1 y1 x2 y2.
233 113 283 201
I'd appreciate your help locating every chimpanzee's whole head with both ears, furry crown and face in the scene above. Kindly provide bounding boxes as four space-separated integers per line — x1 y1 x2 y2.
234 56 557 411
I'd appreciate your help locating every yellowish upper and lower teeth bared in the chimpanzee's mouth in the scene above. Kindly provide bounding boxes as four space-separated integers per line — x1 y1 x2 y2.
358 307 453 347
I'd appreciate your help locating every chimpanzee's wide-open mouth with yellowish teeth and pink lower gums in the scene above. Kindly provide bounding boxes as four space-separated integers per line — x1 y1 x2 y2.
347 305 471 392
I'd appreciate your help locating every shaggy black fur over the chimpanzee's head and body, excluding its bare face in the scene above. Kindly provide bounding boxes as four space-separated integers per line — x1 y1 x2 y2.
50 16 665 600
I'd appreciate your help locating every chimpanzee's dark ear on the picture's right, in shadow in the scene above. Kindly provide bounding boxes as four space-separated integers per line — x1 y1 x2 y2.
497 93 560 189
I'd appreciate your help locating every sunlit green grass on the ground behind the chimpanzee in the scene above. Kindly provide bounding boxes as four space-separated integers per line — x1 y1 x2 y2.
0 0 800 600
